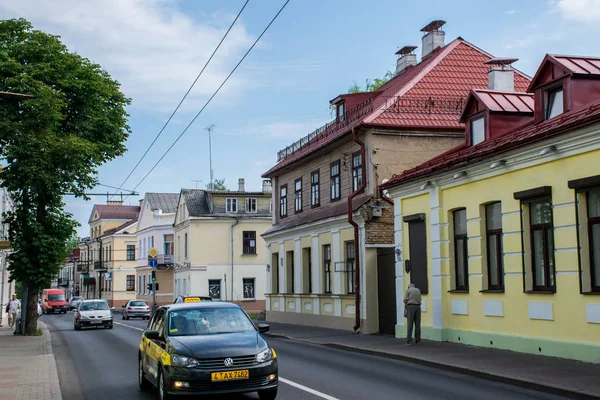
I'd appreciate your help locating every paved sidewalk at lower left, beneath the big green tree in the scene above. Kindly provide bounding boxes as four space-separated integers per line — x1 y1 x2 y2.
0 321 62 400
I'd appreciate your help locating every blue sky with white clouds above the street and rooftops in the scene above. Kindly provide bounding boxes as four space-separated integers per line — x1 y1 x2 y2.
0 0 600 237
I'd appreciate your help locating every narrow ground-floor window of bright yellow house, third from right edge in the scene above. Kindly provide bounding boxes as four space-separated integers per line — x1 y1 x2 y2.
485 202 504 290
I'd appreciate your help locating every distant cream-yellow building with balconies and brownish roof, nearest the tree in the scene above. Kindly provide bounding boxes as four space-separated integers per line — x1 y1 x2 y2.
79 202 140 307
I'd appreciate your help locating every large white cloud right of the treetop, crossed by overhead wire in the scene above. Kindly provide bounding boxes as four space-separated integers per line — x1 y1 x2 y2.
0 0 253 111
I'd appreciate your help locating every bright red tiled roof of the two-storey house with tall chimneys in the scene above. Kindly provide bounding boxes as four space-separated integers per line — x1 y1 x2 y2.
263 38 529 177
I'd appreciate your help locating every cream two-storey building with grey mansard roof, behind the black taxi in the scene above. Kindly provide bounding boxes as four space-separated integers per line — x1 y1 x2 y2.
174 179 271 312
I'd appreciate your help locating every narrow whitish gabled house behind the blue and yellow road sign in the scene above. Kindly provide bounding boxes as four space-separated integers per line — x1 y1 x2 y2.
136 193 179 305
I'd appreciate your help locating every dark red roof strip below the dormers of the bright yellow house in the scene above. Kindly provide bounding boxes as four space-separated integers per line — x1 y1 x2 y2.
381 100 600 189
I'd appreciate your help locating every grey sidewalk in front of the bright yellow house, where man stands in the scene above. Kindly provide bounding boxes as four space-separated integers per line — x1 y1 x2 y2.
261 321 600 399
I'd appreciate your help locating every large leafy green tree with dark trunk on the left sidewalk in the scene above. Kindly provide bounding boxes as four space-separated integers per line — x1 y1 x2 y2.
0 19 130 335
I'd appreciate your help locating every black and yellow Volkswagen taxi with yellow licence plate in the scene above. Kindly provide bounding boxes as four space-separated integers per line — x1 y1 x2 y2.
138 301 278 400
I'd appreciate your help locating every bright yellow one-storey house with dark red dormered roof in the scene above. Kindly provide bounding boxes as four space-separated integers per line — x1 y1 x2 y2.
382 55 600 362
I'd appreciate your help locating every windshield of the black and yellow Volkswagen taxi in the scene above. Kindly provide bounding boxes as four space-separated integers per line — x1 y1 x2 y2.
168 308 255 336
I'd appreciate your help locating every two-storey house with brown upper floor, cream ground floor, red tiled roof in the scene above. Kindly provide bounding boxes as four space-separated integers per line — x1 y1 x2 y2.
263 21 529 334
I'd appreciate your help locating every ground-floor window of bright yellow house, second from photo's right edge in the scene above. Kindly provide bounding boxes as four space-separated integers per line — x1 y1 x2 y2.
529 199 554 291
